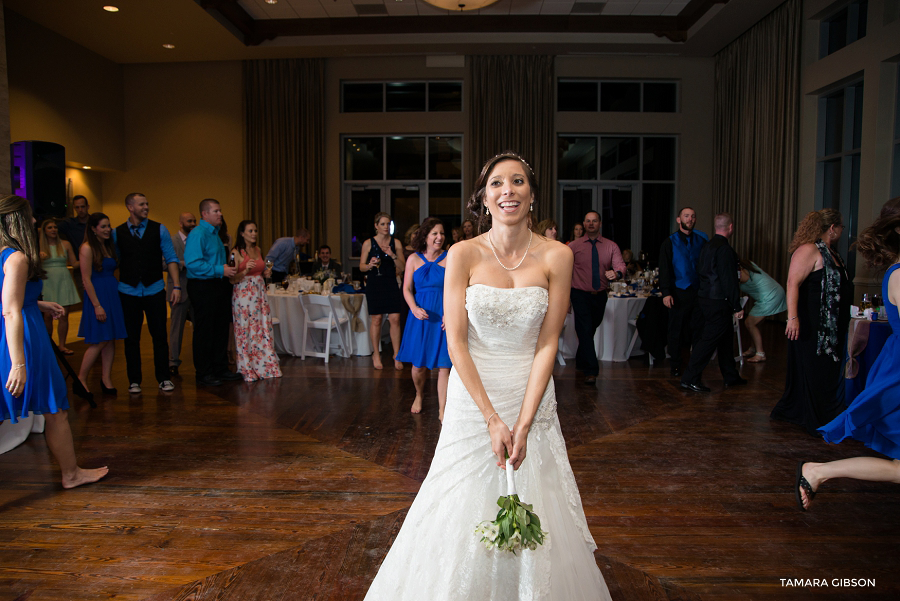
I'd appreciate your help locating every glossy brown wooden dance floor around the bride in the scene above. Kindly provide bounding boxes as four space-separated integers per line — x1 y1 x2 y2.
0 324 900 601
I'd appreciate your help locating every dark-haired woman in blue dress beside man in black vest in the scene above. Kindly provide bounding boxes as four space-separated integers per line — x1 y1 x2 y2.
73 213 128 398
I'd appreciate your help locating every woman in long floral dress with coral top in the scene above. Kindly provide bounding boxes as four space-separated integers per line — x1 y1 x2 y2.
230 220 281 382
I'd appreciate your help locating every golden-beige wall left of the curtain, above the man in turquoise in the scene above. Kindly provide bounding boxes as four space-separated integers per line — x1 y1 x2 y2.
103 61 244 234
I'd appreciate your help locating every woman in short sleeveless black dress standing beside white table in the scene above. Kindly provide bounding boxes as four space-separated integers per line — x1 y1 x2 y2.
359 212 405 369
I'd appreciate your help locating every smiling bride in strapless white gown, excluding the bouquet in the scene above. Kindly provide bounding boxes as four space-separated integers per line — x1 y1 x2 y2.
366 152 610 601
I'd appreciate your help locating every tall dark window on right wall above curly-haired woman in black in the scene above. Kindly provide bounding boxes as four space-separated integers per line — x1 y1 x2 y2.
816 81 863 279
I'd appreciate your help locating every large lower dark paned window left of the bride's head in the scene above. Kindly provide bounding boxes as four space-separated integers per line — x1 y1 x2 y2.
342 134 463 259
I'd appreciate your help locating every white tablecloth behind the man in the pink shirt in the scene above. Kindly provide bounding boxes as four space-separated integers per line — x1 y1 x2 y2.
559 296 647 361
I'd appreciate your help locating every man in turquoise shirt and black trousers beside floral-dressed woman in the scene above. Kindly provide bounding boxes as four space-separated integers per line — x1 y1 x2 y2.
184 198 243 386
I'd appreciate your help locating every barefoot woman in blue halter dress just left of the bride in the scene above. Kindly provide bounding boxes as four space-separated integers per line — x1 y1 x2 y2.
397 217 453 421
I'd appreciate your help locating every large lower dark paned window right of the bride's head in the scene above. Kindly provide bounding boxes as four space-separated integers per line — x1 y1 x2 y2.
557 134 677 262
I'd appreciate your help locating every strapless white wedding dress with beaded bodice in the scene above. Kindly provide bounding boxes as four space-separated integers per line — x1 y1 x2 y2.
366 284 610 601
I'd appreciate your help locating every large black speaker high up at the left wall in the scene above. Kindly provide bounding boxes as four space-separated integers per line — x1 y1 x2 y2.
11 140 66 221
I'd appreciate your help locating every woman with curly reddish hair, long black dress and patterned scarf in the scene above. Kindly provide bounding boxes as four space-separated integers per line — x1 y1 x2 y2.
771 209 852 436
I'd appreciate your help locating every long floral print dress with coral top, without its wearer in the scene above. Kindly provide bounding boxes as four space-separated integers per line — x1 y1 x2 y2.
231 255 281 382
